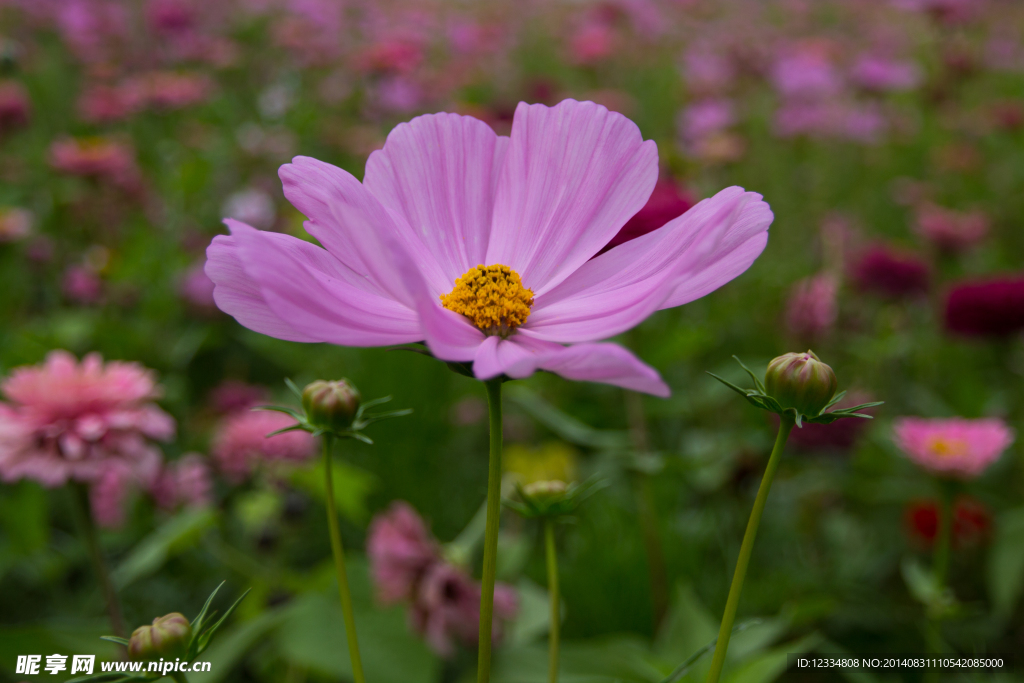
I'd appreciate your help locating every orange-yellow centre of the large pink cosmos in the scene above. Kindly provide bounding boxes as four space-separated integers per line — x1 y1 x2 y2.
441 264 534 339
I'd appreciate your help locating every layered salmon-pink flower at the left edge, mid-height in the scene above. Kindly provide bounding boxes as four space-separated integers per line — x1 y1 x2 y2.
0 351 174 486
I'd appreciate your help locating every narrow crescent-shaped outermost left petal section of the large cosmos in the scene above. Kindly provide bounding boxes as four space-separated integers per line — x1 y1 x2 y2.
205 221 318 342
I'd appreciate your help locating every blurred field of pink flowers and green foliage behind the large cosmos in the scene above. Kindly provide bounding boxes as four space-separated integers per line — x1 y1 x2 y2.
0 0 1024 683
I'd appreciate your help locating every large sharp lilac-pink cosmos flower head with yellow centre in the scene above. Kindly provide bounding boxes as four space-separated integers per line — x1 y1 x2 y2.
206 100 773 396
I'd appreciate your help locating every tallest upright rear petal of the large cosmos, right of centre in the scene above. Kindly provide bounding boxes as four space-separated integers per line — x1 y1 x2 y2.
484 99 657 296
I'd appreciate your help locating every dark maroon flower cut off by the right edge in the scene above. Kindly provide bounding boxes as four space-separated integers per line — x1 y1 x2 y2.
945 275 1024 337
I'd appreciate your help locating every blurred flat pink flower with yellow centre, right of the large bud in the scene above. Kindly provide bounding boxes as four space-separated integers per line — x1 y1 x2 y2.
893 418 1014 479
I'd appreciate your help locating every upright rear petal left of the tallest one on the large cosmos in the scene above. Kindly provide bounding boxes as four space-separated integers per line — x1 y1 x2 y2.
362 114 509 284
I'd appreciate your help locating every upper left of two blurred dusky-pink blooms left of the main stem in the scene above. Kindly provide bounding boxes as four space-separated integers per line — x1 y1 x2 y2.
367 501 440 604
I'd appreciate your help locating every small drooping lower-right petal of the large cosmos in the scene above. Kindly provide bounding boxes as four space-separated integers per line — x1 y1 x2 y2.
538 343 672 398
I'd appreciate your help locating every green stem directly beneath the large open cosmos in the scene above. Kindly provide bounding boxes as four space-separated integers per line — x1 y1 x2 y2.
476 377 502 683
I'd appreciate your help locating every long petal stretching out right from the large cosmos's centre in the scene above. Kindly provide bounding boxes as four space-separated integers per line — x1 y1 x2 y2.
523 187 772 342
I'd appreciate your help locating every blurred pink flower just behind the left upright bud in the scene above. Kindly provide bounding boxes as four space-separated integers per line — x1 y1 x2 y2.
213 411 316 481
